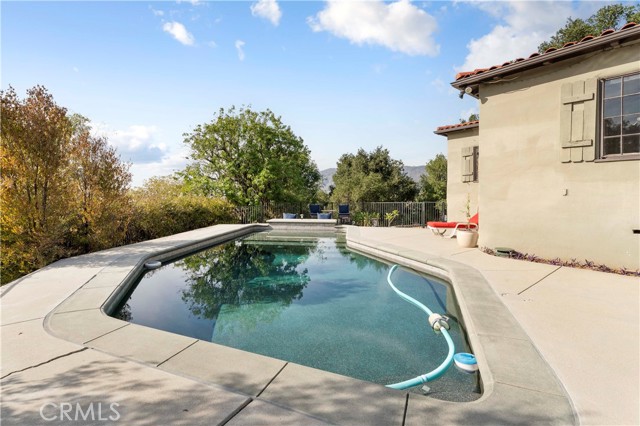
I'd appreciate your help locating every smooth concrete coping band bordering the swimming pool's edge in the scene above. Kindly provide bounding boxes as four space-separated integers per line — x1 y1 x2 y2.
44 224 577 424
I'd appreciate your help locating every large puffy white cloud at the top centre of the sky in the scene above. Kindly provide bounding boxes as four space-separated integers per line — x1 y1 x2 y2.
307 0 440 56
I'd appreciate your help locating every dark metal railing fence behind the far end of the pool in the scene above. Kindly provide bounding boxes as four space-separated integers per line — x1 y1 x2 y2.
235 201 446 226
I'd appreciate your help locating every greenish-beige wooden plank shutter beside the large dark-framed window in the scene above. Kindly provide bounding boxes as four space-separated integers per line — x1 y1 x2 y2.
560 78 598 163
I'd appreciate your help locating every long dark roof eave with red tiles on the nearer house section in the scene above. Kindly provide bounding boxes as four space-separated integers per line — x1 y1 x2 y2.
451 26 640 90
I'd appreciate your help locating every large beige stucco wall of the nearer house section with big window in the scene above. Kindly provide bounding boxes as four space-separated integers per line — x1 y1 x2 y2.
476 44 640 269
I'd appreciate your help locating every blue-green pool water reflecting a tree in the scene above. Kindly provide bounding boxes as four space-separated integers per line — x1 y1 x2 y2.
114 231 480 401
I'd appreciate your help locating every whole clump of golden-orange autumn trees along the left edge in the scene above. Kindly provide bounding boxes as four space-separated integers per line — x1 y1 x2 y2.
0 86 130 283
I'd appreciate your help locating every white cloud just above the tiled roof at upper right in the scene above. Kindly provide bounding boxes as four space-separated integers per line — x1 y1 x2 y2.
456 1 593 71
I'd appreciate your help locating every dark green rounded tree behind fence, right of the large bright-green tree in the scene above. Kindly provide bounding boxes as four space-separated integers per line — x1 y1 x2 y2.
331 146 418 203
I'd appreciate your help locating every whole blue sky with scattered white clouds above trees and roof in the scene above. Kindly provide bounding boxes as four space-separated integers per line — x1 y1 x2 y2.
0 0 603 186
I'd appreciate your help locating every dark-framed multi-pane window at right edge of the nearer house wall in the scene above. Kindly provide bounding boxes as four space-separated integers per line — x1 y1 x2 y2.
600 73 640 158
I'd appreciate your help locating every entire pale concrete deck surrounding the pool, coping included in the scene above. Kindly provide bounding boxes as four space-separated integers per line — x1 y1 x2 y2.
0 225 640 425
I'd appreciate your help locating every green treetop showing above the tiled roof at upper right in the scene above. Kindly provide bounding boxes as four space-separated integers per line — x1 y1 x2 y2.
538 4 640 53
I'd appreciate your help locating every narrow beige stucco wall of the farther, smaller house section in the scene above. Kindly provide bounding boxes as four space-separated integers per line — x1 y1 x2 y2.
447 127 482 222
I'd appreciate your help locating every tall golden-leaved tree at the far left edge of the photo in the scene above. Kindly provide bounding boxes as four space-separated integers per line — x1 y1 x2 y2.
0 86 72 282
